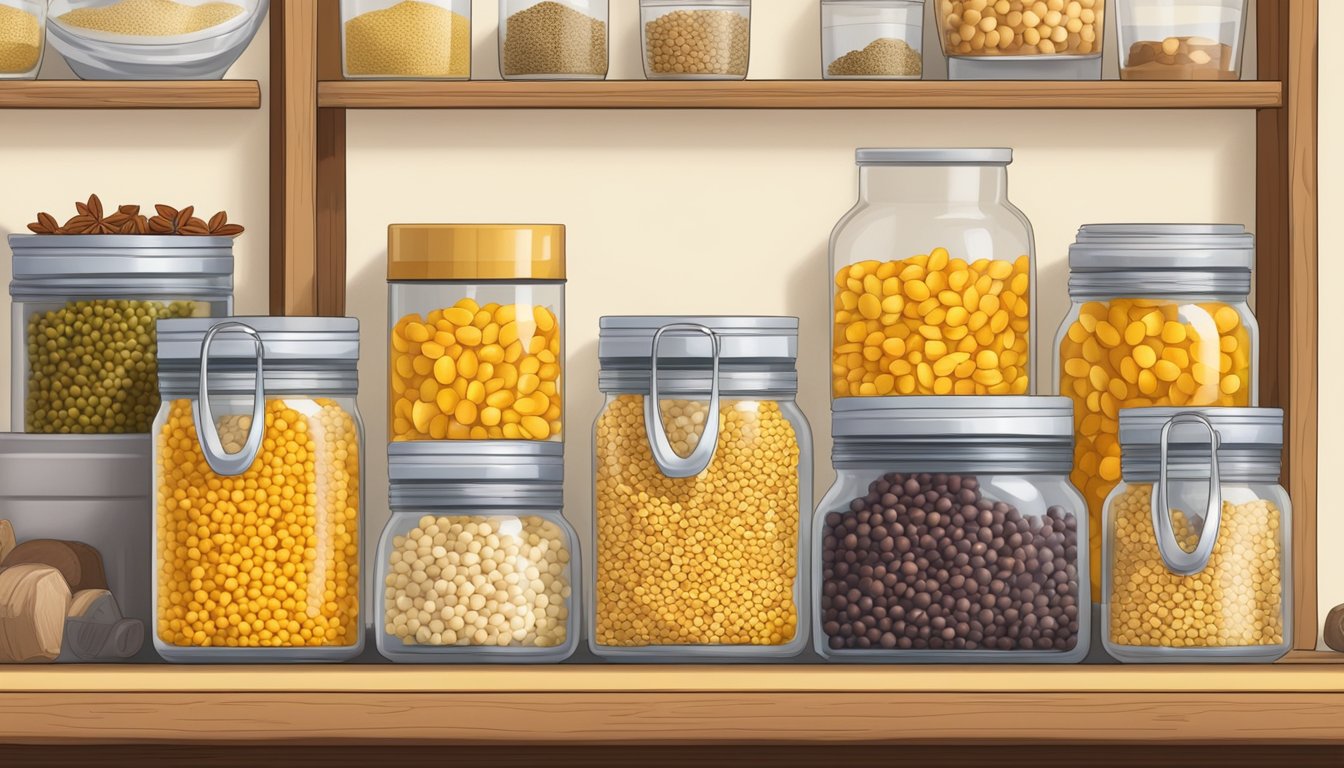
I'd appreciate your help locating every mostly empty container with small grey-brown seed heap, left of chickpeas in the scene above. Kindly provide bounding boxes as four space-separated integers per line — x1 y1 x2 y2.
821 0 923 79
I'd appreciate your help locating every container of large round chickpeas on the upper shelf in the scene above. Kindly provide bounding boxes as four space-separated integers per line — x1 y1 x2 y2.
934 0 1106 79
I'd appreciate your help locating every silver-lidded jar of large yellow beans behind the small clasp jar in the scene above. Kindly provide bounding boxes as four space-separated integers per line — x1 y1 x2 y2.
1054 225 1259 600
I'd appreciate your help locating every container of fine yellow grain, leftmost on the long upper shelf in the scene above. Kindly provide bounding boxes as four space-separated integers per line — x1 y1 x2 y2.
340 0 472 79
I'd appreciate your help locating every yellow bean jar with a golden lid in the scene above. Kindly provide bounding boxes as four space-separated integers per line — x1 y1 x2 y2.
387 225 564 443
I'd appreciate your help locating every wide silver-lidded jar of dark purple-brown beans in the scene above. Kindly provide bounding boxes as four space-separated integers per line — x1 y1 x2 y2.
812 397 1091 663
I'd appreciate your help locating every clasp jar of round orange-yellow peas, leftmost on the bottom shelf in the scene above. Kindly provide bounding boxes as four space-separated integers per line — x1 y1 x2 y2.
153 317 364 663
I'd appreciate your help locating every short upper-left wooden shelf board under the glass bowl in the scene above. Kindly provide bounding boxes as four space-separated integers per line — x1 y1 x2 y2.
0 79 261 109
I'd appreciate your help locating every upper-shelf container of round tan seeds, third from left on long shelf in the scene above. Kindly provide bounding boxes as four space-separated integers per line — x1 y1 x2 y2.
640 0 751 79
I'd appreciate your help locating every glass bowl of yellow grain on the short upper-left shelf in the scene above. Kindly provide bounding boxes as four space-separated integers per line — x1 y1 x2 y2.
48 0 270 79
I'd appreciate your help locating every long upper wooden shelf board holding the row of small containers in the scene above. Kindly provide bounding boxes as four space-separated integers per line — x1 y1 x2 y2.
317 81 1284 109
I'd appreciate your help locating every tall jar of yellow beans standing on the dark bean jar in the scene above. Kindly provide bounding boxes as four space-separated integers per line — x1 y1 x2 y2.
831 149 1036 398
